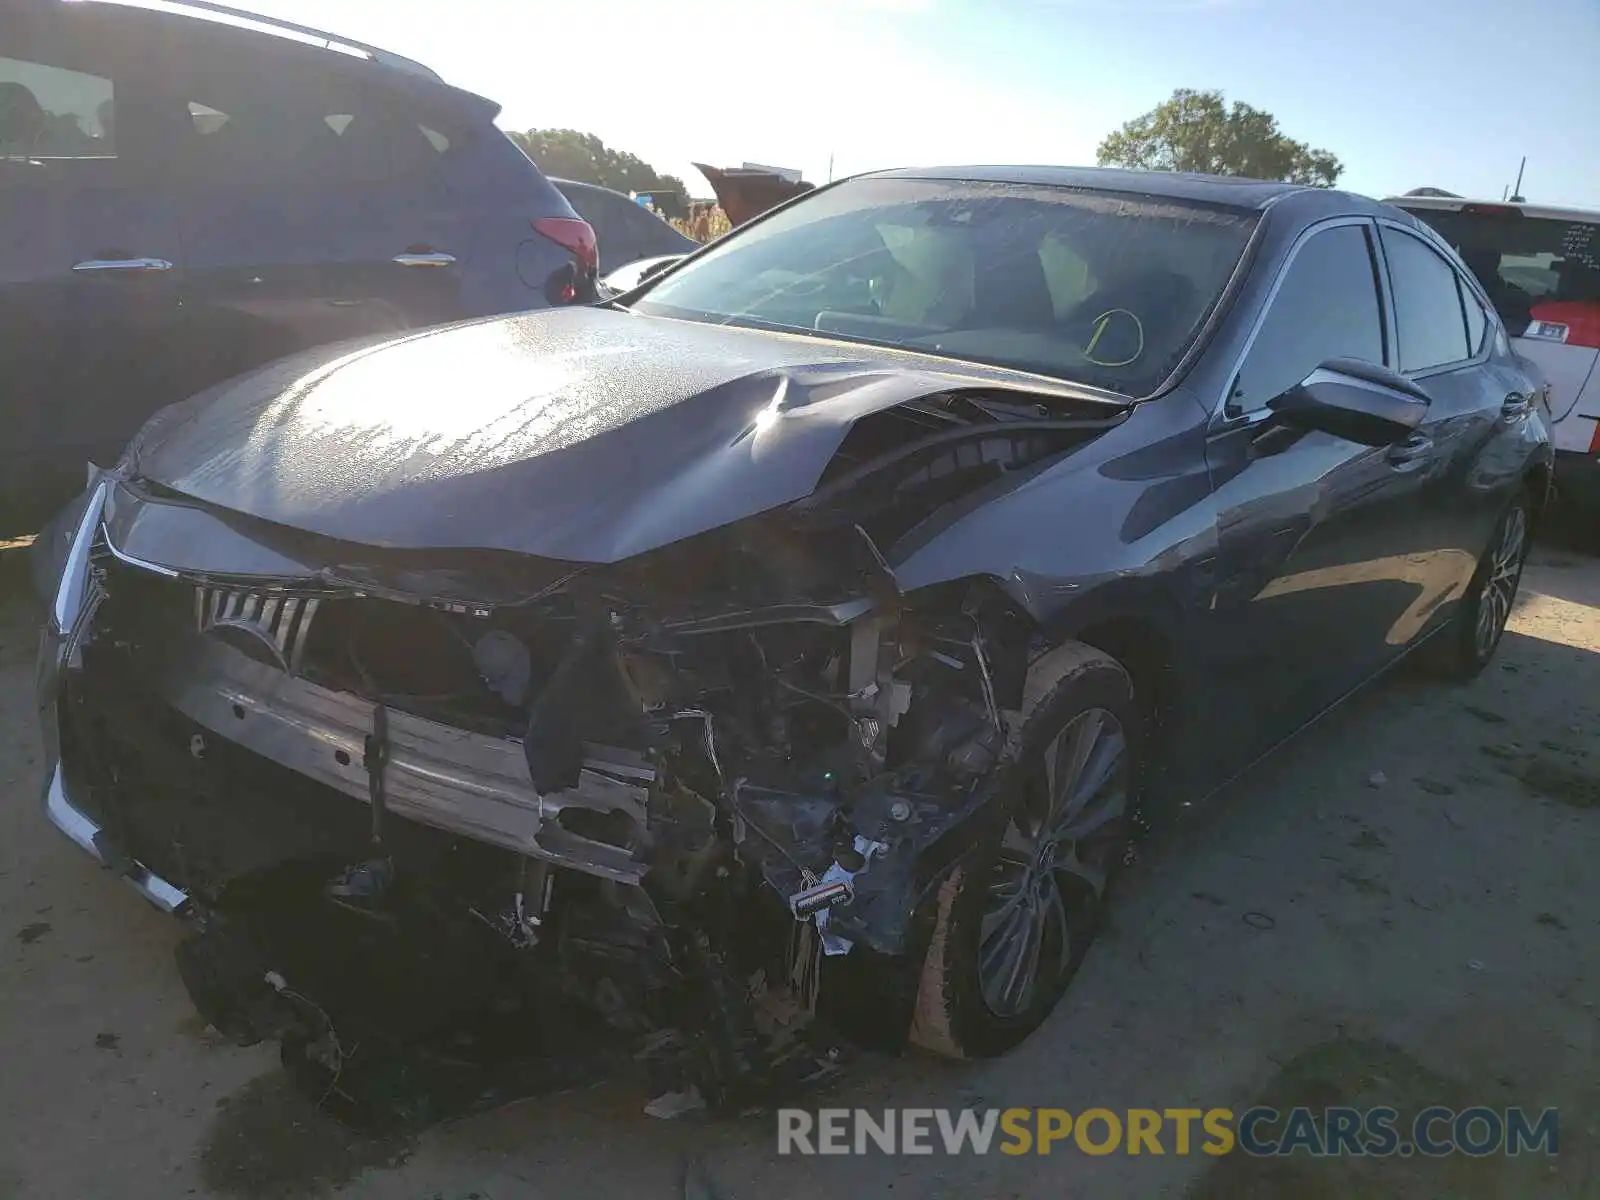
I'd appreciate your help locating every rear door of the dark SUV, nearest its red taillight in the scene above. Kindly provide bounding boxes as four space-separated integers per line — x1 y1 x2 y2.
156 54 472 378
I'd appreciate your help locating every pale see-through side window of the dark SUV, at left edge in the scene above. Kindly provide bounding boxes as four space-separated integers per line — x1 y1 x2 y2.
0 58 117 162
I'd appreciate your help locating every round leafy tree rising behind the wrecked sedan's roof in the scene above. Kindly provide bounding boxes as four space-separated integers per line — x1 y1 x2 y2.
1098 88 1344 187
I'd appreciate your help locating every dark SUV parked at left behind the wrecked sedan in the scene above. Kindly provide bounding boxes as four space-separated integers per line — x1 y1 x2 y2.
0 0 598 515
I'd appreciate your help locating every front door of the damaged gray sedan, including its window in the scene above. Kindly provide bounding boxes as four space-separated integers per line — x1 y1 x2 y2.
1192 221 1440 782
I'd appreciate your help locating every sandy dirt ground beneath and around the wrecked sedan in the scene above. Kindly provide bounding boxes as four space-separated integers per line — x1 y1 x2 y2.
0 534 1600 1200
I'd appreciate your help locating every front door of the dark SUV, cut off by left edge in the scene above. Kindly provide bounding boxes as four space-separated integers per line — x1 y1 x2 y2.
0 27 182 504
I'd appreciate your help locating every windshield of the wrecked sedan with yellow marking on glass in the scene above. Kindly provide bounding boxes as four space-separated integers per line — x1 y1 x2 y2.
634 178 1254 397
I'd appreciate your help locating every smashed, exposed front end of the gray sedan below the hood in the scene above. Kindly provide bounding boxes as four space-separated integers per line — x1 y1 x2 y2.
50 390 1126 1120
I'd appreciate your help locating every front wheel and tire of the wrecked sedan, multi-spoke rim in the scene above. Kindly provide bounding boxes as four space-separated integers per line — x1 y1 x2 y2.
910 642 1142 1058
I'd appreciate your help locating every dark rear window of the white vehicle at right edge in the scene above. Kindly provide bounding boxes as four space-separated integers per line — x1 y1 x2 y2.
1408 208 1600 334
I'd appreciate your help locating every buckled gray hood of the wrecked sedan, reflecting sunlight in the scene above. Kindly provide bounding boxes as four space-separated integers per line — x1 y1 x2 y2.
126 307 1118 563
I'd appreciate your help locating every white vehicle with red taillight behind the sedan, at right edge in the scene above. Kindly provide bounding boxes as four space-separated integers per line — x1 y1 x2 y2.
1386 195 1600 515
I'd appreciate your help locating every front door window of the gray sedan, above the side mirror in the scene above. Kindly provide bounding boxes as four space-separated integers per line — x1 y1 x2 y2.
1227 226 1384 414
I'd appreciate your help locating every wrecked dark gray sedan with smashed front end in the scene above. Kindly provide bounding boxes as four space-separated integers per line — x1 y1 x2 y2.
40 168 1550 1115
